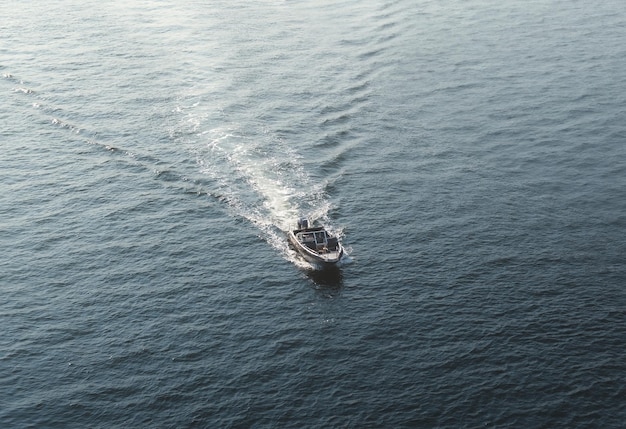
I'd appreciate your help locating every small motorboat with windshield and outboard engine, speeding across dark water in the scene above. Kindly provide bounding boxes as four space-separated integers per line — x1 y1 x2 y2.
289 218 343 267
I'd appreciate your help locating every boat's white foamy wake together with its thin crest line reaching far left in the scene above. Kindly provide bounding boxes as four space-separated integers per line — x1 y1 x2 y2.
3 74 342 269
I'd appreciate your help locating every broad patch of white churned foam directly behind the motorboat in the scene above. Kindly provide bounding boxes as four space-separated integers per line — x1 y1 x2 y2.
173 105 342 269
